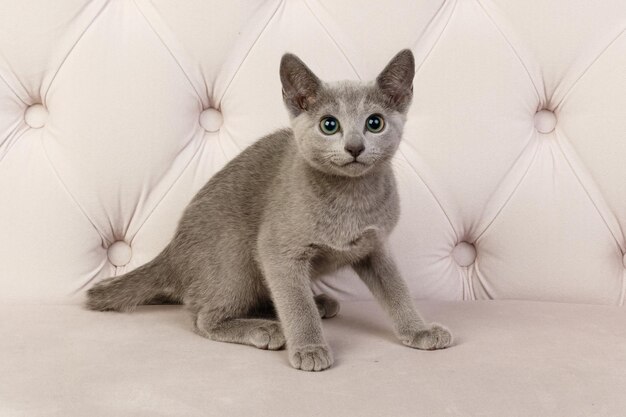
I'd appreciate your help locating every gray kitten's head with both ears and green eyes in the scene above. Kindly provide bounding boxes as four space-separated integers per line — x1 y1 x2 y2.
280 49 415 177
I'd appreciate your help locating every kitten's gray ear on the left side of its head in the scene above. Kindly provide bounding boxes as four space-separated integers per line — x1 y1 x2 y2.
280 53 322 117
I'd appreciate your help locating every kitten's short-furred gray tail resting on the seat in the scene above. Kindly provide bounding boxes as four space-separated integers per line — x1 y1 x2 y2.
86 253 176 311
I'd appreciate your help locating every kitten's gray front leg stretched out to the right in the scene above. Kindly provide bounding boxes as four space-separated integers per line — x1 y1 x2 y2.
353 243 452 350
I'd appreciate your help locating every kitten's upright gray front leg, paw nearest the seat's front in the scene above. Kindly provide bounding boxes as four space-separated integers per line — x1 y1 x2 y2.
259 240 333 371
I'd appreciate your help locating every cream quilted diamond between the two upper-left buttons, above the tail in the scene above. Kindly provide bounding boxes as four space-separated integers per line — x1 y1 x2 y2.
44 2 204 242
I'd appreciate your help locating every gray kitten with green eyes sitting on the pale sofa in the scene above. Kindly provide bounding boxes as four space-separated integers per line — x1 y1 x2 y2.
87 50 452 371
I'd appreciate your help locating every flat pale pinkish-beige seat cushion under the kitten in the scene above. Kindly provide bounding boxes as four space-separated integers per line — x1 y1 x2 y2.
0 301 626 417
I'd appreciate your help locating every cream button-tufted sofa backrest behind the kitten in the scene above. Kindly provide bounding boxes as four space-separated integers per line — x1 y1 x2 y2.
0 0 626 304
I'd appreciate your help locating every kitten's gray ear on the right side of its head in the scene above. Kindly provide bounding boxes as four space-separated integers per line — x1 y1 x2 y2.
376 49 415 113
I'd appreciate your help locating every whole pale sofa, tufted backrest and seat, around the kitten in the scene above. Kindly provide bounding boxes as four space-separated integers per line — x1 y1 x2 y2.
0 0 626 417
